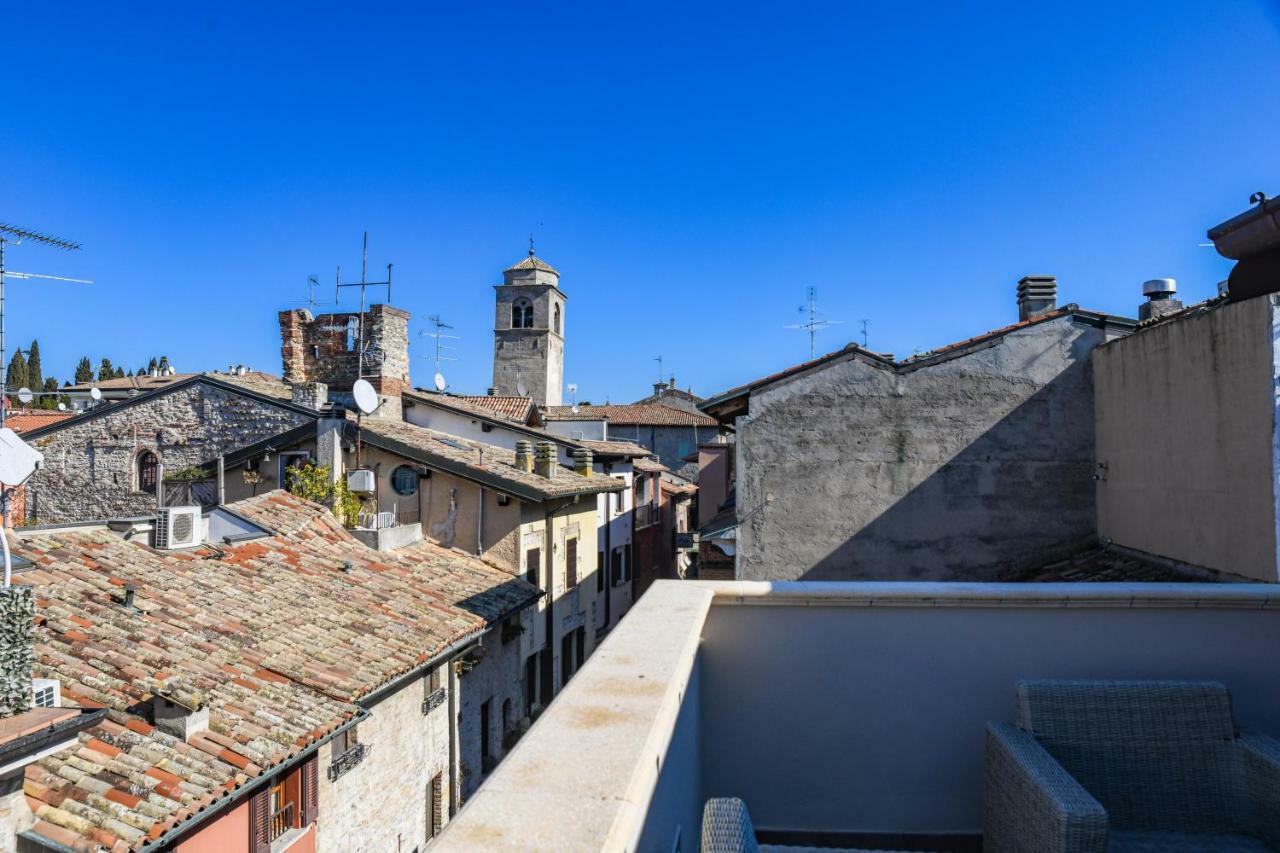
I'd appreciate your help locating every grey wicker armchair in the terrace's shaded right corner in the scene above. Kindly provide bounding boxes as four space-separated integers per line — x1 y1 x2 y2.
983 681 1280 853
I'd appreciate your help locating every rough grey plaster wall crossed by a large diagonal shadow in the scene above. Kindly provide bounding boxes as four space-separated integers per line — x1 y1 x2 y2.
737 318 1105 580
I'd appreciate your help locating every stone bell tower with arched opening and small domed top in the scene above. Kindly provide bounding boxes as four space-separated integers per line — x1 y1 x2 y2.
493 250 567 406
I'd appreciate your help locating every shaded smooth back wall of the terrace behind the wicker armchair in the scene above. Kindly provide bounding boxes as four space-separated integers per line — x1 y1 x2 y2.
700 601 1280 834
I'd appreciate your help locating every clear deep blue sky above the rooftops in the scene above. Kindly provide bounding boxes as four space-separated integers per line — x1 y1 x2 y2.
0 0 1280 402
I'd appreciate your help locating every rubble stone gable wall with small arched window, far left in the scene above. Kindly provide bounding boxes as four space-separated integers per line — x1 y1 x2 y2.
28 383 308 521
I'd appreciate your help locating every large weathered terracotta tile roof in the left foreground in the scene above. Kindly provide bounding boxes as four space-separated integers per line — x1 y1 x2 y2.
14 492 538 850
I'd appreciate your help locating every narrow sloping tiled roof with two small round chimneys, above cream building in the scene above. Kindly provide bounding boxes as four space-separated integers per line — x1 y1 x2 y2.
362 418 620 500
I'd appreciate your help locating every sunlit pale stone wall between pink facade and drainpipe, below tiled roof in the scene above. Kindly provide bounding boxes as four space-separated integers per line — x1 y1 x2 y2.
316 665 451 853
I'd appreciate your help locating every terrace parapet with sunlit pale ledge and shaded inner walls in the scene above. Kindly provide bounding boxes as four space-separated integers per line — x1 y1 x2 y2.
438 573 1280 853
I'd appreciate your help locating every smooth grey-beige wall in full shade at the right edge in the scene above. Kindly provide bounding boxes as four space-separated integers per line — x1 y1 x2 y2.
1093 296 1277 581
